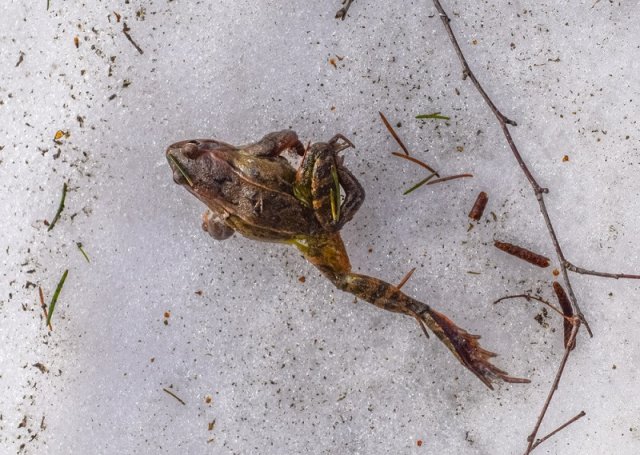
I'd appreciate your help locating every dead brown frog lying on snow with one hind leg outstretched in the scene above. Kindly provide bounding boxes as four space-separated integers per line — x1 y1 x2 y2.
166 130 529 389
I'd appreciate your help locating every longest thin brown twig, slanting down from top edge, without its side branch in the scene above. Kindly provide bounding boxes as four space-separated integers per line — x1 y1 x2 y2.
433 0 593 336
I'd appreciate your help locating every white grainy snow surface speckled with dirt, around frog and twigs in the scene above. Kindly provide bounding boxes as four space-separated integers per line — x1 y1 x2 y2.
0 0 640 455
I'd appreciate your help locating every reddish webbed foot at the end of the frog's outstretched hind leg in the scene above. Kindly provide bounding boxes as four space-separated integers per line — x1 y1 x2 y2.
415 308 530 389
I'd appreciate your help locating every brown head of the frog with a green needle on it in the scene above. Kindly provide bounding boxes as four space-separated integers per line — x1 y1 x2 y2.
166 139 234 206
